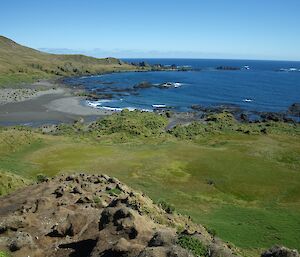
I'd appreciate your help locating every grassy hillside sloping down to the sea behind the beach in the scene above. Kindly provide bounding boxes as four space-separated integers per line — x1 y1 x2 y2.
0 36 136 84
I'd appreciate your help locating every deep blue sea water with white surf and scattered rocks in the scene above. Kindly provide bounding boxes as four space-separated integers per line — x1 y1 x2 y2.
66 59 300 112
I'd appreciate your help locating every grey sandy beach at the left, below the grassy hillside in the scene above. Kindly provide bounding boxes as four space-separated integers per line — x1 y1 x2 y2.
0 81 112 126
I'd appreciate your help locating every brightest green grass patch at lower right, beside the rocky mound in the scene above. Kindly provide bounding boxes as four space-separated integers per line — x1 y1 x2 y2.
197 205 300 249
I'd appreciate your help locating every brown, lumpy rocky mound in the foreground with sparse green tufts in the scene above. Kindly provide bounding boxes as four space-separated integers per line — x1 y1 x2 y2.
0 174 299 257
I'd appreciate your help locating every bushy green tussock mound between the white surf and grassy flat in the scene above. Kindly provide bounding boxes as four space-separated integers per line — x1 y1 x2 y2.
52 110 169 143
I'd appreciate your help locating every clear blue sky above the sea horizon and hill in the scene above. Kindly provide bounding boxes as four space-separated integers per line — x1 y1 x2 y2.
0 0 300 60
